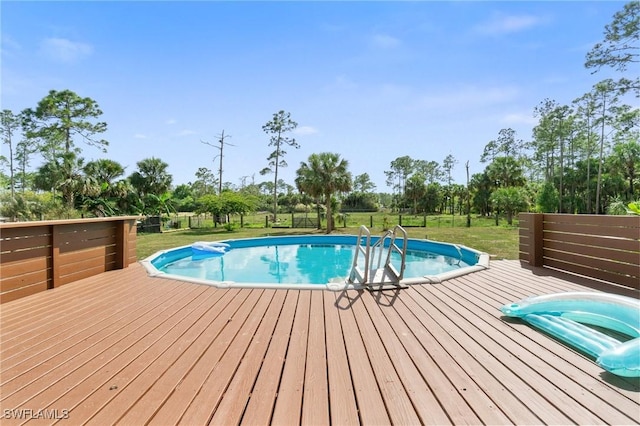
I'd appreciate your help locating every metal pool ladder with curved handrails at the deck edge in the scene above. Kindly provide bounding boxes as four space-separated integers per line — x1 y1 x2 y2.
347 225 407 290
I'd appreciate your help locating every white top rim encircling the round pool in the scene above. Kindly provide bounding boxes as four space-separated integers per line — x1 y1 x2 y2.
139 235 490 291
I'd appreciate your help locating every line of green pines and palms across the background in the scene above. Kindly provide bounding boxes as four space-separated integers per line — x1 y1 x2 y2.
0 2 640 231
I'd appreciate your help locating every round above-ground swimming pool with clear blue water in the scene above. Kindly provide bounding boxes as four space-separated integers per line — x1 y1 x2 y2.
141 235 489 290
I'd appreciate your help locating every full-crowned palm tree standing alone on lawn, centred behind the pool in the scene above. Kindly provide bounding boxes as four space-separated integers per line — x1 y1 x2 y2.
296 152 352 234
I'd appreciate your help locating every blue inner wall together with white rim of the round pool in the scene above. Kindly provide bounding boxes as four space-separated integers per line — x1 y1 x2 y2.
140 235 489 291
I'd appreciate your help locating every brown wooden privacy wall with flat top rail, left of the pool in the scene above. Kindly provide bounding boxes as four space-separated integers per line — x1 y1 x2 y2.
0 216 137 303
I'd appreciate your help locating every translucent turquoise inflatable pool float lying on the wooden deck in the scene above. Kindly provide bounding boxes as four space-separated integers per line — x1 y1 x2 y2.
500 292 640 377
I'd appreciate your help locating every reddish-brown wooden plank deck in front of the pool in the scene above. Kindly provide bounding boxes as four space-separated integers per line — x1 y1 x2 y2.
0 261 640 426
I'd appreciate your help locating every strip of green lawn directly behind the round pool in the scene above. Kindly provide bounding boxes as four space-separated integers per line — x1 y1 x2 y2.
136 213 518 259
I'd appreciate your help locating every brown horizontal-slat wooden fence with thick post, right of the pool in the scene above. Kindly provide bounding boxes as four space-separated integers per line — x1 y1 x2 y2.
519 213 640 289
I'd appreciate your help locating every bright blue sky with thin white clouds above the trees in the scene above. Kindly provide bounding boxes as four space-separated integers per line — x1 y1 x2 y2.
0 1 624 192
